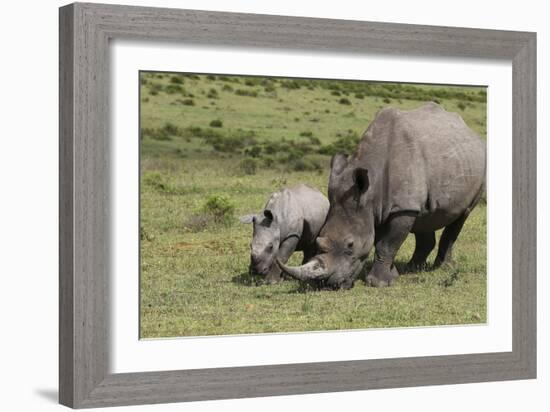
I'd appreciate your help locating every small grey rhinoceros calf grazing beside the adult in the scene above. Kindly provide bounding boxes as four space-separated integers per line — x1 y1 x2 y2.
240 185 329 283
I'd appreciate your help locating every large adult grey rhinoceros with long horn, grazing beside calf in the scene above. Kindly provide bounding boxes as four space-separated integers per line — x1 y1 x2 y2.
280 103 486 289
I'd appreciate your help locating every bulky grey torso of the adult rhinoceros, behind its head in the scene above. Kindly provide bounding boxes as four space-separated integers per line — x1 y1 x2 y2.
362 103 486 231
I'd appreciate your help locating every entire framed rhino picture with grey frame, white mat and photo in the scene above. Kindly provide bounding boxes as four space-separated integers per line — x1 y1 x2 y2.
60 3 536 408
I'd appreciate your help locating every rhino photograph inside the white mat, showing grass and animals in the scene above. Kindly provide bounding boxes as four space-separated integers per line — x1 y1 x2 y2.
139 71 487 338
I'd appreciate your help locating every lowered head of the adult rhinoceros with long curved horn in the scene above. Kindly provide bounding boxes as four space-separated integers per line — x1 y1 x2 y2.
277 155 374 289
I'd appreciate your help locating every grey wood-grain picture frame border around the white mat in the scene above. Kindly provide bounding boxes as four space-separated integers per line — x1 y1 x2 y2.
59 3 536 408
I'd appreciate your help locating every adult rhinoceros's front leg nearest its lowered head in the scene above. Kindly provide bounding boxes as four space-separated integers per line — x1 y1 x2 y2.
366 213 416 287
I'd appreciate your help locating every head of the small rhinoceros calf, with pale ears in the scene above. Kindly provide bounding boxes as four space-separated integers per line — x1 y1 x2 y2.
240 209 280 276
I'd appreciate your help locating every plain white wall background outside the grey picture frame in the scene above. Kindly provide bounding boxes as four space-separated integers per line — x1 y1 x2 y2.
0 0 550 412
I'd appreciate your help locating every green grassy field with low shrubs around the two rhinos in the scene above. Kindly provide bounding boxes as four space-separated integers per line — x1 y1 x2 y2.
140 73 486 338
